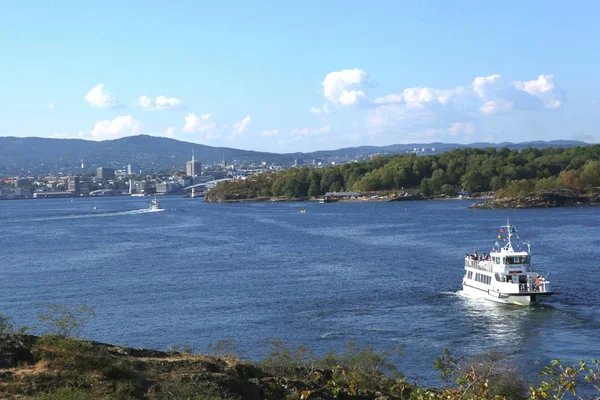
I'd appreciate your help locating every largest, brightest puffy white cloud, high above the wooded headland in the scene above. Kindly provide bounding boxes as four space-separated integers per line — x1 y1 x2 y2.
322 69 367 106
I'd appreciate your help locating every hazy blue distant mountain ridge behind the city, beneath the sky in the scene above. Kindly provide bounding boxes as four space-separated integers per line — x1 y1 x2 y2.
0 135 588 176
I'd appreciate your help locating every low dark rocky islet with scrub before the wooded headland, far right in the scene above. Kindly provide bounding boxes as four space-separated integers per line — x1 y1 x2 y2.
468 189 600 210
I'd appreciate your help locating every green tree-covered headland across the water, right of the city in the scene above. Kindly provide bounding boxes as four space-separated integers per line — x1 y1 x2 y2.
207 145 600 201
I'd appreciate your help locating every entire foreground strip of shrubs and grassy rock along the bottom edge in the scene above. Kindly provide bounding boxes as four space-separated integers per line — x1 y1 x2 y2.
0 306 600 400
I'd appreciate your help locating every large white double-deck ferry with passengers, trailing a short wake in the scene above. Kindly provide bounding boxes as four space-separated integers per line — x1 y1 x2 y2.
463 221 553 305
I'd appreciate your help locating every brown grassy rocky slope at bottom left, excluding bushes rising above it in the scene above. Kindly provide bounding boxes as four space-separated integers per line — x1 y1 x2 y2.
0 334 411 400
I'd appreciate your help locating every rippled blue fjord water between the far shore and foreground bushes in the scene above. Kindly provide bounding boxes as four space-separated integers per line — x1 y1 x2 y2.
0 197 600 383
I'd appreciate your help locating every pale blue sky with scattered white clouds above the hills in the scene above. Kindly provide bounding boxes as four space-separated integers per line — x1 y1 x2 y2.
0 0 600 153
